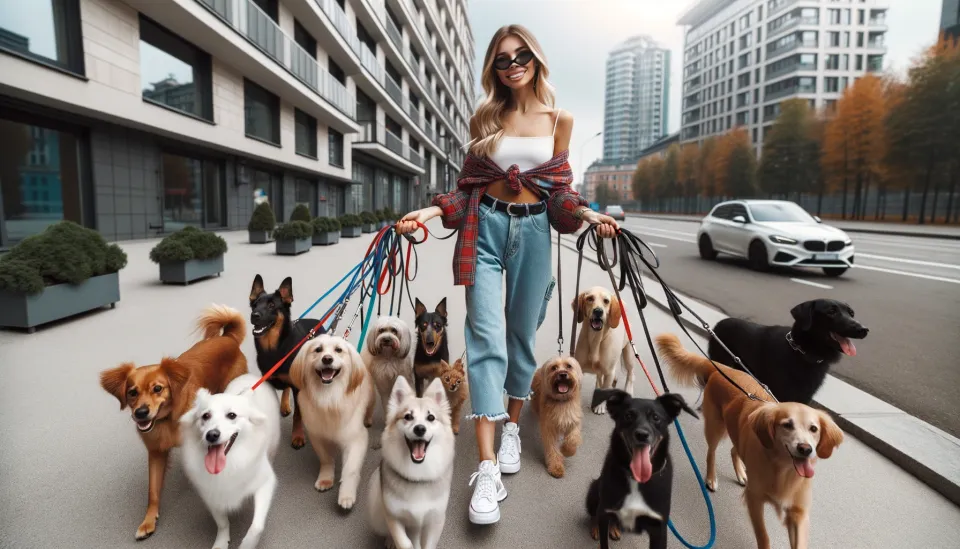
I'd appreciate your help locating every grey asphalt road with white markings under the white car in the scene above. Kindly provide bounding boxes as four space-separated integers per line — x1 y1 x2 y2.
625 217 960 436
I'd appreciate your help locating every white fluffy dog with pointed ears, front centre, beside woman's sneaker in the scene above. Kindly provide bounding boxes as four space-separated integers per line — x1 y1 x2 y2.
368 377 455 549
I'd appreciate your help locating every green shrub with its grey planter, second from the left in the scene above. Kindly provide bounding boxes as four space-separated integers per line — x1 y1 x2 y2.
150 227 227 285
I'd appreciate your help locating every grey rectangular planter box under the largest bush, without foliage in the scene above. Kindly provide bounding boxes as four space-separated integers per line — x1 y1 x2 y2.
0 273 120 333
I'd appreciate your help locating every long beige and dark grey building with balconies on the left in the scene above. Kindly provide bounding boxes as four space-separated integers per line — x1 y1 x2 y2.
0 0 474 249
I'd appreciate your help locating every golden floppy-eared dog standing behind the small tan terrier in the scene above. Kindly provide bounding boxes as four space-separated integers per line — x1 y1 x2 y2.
573 286 633 414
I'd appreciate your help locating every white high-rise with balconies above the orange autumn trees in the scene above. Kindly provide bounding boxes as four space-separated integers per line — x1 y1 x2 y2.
678 0 888 151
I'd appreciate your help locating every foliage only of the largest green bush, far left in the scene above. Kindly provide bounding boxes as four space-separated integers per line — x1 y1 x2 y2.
0 221 127 295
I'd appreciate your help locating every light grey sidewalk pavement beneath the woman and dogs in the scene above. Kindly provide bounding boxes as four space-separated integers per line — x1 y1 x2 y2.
0 223 960 549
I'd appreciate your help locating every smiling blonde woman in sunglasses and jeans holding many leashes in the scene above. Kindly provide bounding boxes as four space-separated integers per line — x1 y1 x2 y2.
397 25 618 524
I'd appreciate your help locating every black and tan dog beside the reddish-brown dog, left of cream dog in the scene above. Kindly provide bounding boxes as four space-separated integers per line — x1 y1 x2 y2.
250 275 326 450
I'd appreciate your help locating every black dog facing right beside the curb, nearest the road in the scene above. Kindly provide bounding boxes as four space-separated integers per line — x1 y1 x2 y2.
709 299 869 404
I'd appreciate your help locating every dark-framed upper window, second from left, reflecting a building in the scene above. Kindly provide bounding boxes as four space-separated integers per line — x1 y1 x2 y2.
140 15 213 121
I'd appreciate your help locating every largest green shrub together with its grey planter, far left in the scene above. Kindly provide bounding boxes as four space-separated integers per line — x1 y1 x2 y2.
0 221 127 333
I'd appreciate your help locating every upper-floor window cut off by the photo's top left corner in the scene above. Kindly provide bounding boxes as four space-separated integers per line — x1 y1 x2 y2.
0 0 84 74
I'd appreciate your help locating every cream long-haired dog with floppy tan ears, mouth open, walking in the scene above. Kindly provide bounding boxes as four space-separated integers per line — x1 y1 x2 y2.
290 334 376 509
